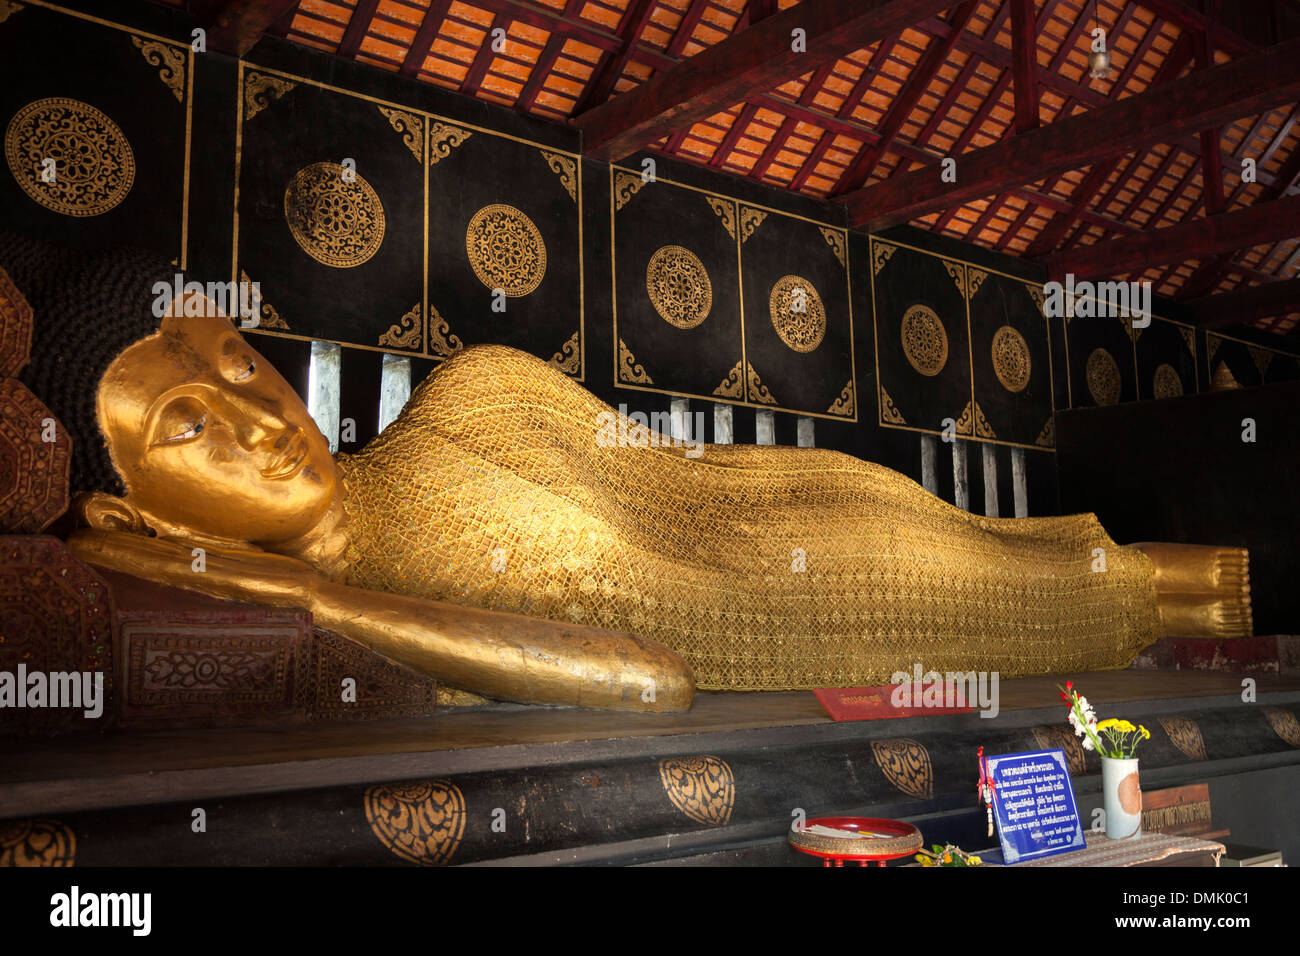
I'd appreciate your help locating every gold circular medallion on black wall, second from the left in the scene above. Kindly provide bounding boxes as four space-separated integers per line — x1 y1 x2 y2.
285 163 385 269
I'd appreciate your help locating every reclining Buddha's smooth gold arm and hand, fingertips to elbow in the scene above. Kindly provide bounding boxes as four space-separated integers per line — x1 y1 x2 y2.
68 529 696 711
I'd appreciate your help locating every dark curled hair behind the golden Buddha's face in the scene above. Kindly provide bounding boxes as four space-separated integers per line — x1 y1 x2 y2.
0 232 172 494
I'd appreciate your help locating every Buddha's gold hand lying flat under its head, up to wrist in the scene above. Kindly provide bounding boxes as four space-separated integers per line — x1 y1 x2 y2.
68 528 321 609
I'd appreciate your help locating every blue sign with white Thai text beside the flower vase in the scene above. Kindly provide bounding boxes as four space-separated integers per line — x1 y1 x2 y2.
988 750 1084 864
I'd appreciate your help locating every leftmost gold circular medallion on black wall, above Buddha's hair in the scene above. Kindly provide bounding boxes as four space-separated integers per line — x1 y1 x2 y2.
4 96 135 217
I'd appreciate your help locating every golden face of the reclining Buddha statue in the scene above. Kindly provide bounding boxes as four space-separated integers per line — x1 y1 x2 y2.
96 310 337 545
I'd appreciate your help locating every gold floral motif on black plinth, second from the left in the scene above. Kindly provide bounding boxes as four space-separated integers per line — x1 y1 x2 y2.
364 780 465 866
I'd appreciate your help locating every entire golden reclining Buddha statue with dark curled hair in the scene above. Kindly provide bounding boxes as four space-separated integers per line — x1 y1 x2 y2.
0 237 1249 710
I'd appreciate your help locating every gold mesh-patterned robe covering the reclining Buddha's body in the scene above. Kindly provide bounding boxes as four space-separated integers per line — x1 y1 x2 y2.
339 346 1160 691
